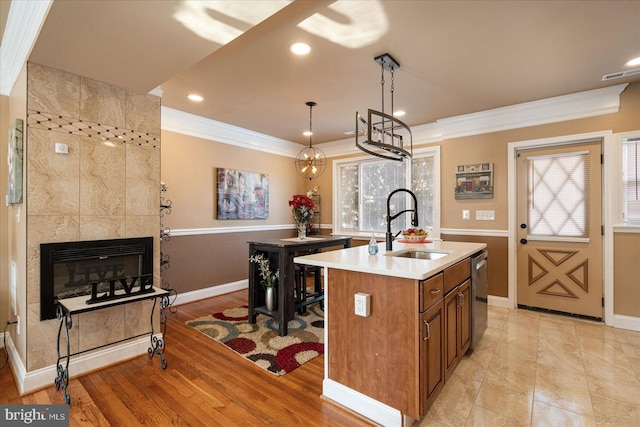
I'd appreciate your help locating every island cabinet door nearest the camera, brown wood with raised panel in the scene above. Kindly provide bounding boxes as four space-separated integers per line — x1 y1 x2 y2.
420 300 445 417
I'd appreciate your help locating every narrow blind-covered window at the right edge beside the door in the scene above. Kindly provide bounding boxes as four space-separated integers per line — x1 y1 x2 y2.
622 136 640 221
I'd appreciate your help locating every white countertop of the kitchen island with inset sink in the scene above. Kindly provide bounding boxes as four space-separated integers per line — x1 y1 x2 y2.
293 241 487 280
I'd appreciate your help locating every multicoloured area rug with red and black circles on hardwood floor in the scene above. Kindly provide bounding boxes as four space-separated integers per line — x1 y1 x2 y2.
185 304 324 376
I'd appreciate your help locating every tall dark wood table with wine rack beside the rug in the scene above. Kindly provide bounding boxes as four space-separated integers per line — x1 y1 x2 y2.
247 236 351 336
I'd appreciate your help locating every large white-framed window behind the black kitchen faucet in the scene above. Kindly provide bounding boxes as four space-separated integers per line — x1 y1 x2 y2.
333 147 440 235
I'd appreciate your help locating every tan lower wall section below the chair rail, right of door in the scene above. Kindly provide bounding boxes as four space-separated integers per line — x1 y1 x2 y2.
613 233 640 317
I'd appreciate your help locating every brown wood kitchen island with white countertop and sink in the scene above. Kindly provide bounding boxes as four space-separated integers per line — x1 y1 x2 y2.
294 242 486 426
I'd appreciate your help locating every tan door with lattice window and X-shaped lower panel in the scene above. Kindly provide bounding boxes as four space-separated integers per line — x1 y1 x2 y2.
516 140 603 319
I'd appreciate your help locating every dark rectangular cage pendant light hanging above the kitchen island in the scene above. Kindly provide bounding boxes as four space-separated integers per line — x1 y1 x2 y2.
356 53 413 162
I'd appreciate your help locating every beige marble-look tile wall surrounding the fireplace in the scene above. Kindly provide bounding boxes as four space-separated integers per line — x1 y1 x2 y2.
25 63 160 371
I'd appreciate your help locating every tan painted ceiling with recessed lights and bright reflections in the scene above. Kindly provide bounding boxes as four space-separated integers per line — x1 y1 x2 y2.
8 0 640 144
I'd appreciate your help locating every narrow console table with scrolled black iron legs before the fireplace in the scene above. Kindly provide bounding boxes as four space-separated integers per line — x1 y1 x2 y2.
54 287 170 404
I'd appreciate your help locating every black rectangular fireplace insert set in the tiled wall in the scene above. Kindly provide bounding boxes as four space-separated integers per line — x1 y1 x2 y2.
40 237 153 320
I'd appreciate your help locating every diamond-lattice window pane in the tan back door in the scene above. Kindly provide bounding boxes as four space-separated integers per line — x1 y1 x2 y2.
527 151 589 238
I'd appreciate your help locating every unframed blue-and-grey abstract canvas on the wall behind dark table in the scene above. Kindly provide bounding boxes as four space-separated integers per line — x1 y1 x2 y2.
216 168 269 219
